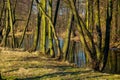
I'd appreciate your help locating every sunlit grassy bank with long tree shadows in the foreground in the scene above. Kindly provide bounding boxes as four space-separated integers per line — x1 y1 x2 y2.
0 48 120 80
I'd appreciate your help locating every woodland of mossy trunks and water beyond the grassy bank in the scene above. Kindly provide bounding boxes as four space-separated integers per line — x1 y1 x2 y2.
0 0 120 79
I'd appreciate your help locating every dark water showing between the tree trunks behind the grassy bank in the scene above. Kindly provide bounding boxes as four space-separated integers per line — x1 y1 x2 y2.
8 35 120 73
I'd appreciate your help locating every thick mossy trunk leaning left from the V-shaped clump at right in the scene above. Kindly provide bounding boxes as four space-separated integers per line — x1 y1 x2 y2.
66 0 97 68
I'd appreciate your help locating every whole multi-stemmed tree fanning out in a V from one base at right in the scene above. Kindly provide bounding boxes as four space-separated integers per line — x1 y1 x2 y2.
64 0 112 71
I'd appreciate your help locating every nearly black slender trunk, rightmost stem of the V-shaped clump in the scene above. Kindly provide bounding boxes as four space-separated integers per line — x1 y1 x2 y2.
101 0 113 71
